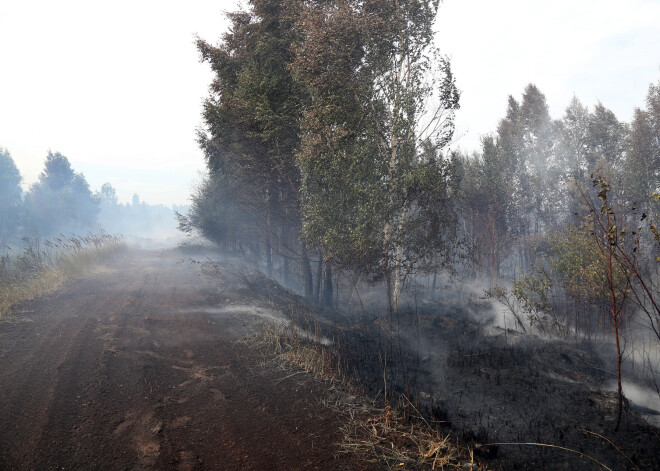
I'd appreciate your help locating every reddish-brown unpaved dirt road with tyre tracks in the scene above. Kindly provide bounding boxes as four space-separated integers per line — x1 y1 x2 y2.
0 252 372 470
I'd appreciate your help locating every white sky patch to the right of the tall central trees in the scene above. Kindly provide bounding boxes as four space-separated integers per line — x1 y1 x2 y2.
436 0 660 151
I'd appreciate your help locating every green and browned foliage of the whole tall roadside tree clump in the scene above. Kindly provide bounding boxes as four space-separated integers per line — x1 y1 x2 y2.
186 0 459 310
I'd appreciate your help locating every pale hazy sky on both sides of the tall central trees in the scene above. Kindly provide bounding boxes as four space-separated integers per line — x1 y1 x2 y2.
0 0 660 205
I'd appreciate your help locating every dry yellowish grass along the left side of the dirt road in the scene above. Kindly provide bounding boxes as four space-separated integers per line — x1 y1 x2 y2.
0 233 126 318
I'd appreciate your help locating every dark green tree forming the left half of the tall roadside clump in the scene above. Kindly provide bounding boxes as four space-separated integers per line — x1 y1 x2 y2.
190 0 312 298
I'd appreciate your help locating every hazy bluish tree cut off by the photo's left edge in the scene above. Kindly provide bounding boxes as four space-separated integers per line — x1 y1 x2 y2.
0 147 23 245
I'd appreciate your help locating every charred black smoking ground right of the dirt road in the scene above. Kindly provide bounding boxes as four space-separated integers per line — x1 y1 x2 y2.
314 302 660 470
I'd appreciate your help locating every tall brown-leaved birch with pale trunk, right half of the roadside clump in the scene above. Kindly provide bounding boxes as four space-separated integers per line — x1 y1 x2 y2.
293 0 459 310
